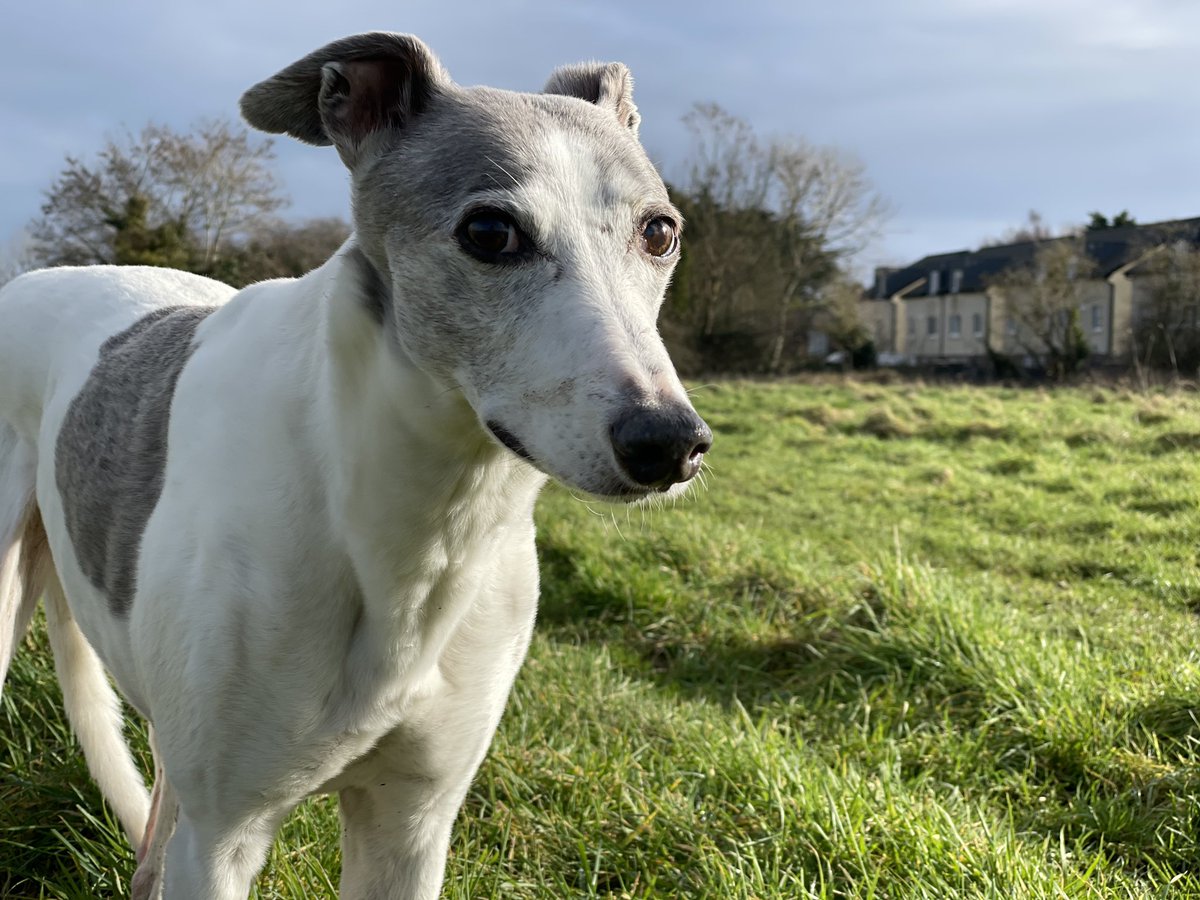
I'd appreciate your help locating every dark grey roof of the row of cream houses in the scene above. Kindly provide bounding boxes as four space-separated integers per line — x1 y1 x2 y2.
870 217 1200 298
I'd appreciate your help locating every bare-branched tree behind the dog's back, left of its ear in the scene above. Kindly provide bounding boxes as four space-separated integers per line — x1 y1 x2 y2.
30 121 284 274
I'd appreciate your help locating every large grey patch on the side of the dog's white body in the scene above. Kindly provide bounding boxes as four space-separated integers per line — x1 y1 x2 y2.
54 306 216 616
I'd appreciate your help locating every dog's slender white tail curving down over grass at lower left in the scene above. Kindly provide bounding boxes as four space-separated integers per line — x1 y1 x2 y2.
46 578 150 847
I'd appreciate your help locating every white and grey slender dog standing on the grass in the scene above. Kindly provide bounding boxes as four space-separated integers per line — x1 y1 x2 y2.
0 32 712 900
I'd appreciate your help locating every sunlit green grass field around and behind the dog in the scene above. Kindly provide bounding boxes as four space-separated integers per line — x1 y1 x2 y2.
0 380 1200 898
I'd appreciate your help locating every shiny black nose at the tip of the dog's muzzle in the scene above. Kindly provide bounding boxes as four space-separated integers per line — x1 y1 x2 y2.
608 403 713 491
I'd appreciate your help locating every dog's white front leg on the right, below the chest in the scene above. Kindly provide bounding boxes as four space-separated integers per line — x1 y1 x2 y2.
338 773 470 900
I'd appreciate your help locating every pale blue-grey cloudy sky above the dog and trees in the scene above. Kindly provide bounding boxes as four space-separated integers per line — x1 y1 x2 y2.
0 0 1200 278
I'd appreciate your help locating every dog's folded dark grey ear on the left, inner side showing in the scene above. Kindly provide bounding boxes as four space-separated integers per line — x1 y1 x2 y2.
241 31 450 168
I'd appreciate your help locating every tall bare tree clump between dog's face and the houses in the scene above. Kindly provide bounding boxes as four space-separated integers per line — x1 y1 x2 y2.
668 103 886 372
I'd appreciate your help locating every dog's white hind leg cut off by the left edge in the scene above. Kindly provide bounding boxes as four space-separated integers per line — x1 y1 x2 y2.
0 422 43 689
